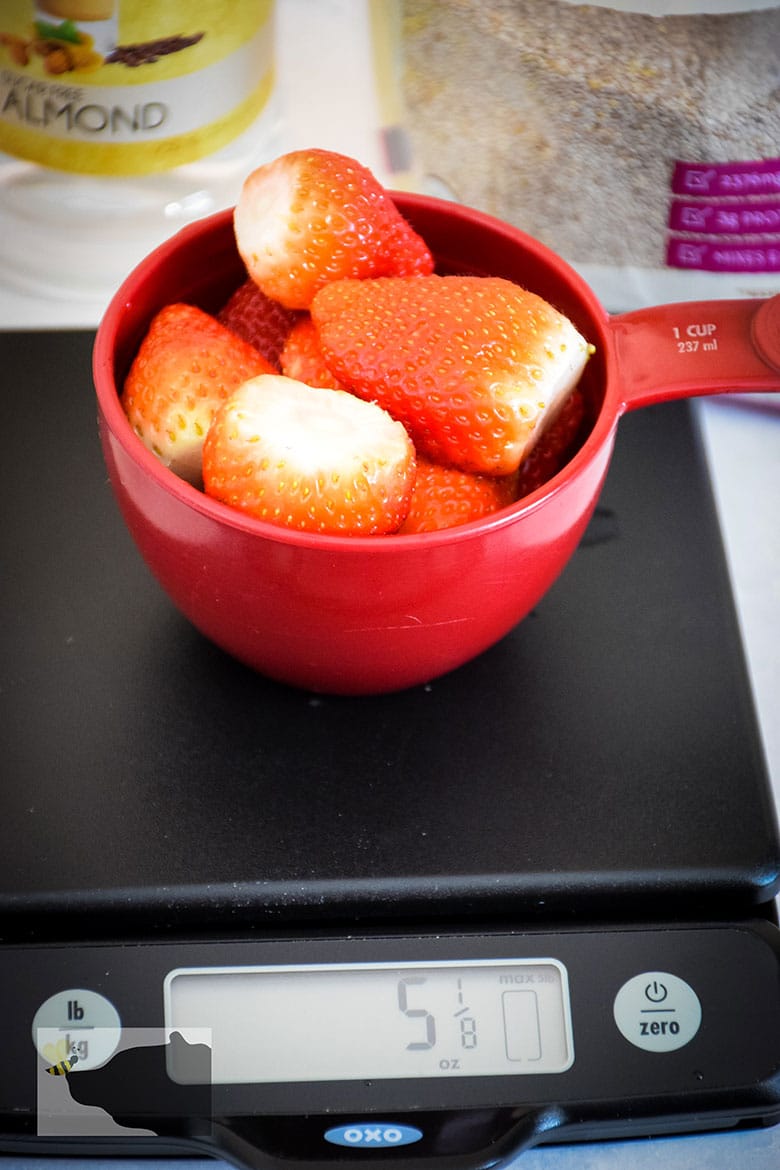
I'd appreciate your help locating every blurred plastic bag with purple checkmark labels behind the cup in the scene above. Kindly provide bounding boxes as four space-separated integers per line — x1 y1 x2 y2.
400 0 780 311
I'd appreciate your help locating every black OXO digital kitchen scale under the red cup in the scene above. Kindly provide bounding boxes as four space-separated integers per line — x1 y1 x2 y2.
0 332 780 1170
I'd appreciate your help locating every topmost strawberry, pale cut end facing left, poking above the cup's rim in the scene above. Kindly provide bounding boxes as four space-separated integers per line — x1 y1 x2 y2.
234 150 433 309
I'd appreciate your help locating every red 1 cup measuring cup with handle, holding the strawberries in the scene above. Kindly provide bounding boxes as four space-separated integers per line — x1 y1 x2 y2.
94 194 780 695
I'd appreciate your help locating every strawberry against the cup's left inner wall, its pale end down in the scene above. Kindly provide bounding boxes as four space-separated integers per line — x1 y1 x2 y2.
122 303 274 484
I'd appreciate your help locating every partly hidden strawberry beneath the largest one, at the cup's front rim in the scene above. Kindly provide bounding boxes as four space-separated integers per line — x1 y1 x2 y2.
399 456 517 534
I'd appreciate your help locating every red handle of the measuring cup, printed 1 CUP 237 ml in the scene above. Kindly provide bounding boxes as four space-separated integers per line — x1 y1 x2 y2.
610 295 780 411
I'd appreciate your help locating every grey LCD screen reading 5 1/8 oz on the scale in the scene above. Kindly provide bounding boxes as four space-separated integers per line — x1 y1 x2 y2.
164 958 574 1085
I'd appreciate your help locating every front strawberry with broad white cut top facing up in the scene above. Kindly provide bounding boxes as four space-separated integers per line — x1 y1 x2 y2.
203 374 415 536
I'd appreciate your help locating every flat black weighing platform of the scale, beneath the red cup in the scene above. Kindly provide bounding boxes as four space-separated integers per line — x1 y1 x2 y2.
0 332 780 938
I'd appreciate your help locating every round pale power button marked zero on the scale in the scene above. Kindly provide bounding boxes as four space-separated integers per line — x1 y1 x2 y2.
613 971 702 1052
